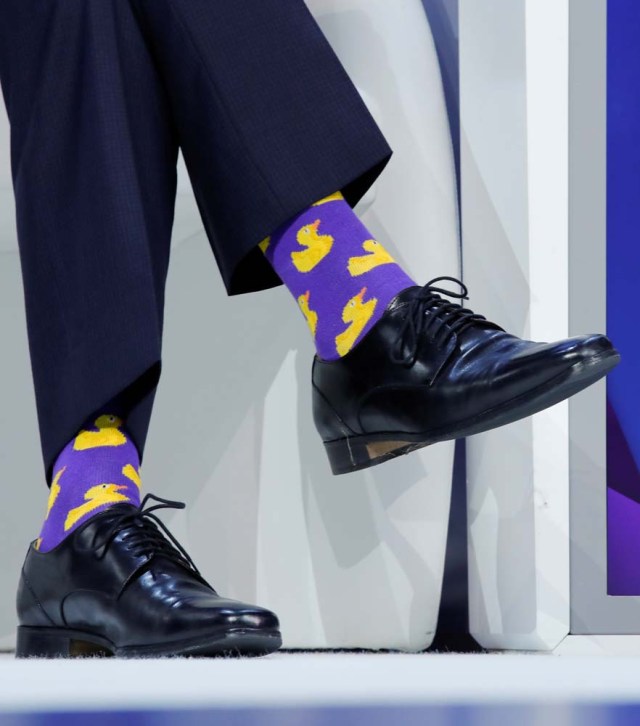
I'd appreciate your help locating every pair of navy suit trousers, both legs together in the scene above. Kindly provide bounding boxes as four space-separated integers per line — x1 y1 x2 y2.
0 0 391 490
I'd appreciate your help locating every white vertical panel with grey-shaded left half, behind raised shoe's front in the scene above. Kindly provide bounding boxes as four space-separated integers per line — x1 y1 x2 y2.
460 0 569 650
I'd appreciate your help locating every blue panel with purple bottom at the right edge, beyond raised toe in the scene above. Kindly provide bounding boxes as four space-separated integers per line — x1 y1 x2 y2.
607 0 640 595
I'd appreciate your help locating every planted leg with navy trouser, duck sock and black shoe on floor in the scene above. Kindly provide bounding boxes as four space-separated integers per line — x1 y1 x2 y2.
0 0 281 657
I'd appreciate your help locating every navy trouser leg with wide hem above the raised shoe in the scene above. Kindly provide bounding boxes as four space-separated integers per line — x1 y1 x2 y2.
132 0 391 294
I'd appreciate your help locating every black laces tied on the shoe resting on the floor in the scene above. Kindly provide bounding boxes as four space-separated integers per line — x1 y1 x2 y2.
85 494 201 577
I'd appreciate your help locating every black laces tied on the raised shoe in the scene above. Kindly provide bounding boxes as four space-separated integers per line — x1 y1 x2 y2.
391 275 487 366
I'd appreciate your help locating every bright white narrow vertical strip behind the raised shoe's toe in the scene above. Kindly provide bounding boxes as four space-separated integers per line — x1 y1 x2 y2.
526 0 570 647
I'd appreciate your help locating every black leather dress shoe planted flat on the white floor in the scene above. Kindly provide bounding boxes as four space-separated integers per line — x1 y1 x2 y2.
16 495 282 658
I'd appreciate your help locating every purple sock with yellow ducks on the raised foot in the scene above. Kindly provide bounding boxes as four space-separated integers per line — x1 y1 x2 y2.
260 192 416 360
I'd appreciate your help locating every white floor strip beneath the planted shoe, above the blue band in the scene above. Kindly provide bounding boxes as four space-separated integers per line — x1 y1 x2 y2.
0 653 640 712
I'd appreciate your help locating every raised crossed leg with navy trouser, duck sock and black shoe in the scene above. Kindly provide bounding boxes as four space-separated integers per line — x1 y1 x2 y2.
132 0 619 473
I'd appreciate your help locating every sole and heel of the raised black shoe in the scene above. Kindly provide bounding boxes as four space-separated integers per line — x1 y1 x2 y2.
324 350 620 474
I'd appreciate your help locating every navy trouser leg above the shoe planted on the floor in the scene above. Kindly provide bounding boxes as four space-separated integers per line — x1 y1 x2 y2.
0 0 177 490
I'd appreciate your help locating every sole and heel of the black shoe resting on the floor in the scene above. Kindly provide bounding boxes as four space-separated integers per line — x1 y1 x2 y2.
16 625 282 658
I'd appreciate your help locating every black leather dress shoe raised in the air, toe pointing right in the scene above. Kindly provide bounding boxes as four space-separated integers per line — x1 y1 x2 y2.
312 277 620 474
